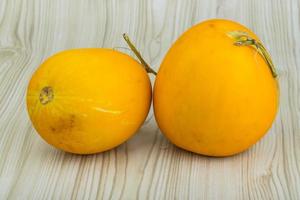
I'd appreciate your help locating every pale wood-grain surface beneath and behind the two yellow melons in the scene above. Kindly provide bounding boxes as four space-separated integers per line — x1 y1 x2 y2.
0 0 300 200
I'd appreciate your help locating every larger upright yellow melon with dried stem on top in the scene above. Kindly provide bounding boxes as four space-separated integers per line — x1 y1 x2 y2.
153 19 279 156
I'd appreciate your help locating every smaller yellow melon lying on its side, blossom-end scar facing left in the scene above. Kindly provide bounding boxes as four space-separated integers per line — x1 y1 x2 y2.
27 48 151 154
